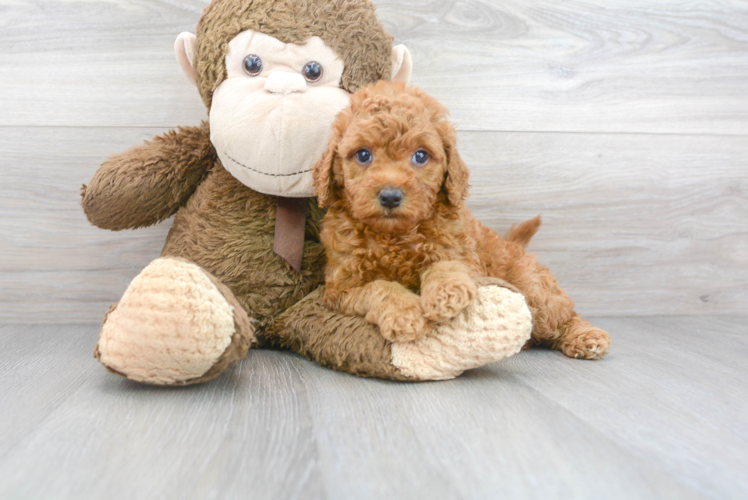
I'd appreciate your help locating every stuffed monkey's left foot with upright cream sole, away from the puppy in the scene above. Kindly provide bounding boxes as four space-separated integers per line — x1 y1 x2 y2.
94 257 254 385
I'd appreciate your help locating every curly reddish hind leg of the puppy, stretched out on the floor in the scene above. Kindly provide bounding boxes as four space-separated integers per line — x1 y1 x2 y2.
506 252 610 359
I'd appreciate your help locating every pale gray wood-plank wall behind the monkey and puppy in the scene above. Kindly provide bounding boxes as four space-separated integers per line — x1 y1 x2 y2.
0 0 748 323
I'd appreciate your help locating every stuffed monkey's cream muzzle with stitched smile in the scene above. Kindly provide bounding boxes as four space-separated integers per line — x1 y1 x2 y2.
210 78 350 198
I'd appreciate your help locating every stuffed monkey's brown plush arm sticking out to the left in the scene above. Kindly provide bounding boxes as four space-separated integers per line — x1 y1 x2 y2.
81 122 216 231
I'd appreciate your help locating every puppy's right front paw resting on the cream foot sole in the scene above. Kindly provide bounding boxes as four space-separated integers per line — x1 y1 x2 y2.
421 274 478 323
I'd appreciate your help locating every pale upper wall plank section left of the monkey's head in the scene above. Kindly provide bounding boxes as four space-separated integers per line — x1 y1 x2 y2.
0 0 208 131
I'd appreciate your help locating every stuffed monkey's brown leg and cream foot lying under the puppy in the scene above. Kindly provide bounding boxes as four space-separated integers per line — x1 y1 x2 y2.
272 278 532 381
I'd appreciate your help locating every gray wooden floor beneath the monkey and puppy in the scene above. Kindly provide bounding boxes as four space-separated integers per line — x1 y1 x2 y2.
0 316 748 500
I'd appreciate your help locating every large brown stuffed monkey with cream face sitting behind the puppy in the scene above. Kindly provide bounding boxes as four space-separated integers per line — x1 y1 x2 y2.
82 0 532 385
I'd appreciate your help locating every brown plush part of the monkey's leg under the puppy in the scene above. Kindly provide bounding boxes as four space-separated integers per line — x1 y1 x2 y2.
273 287 411 380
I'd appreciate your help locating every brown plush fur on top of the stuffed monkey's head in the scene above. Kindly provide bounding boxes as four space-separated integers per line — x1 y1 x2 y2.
194 0 393 109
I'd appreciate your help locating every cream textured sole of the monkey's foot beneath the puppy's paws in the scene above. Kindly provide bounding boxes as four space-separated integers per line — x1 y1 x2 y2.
392 278 532 380
